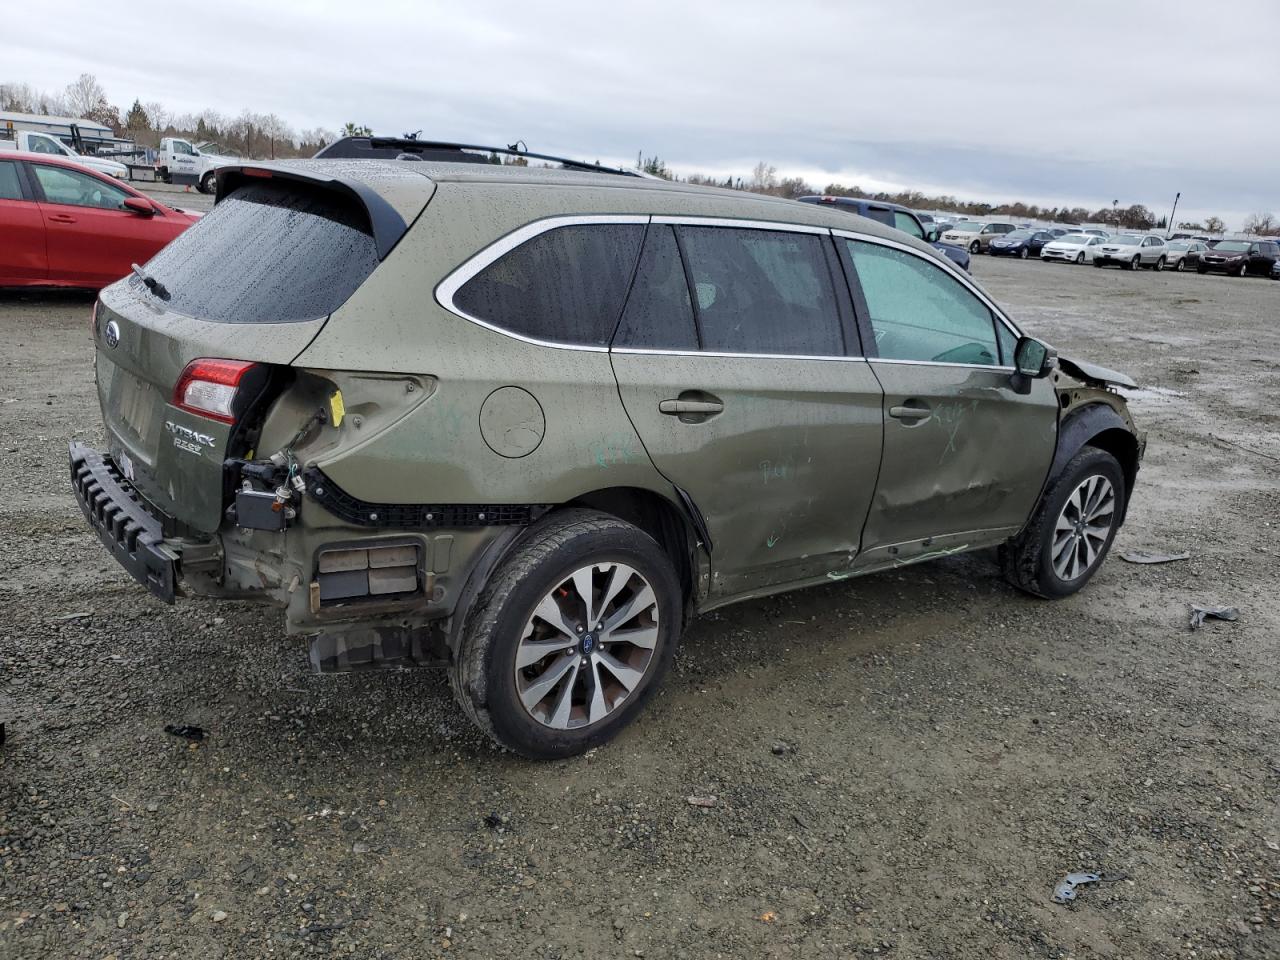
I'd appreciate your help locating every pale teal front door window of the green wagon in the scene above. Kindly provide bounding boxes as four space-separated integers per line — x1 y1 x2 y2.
845 241 1000 366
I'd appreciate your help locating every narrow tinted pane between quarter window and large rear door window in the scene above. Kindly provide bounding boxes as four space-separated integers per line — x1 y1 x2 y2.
613 224 698 349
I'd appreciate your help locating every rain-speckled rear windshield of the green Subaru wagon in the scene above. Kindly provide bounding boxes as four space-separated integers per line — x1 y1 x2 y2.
147 183 378 324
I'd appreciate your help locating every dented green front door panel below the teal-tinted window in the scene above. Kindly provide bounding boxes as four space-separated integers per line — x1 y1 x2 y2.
859 360 1057 566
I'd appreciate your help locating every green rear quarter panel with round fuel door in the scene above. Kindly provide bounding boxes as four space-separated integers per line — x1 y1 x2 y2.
288 183 671 504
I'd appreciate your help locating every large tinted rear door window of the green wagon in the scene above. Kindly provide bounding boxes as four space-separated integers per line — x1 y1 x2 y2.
677 227 845 356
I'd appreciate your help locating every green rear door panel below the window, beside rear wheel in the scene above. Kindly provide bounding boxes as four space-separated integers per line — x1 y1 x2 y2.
613 349 882 596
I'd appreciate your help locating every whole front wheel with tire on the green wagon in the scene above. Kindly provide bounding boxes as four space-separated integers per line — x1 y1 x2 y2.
1000 445 1129 600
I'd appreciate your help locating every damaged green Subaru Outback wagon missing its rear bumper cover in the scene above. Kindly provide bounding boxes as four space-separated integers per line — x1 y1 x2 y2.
70 160 1143 758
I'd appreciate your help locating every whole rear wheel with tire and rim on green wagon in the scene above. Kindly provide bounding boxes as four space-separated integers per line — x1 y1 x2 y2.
449 509 684 759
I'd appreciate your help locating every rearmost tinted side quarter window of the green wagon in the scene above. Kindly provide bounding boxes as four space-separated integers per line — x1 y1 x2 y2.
453 224 644 347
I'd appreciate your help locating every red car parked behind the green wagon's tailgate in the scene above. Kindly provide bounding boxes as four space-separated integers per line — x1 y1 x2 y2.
0 151 196 289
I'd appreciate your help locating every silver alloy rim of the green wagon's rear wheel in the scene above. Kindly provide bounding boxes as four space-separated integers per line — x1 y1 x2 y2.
515 562 659 730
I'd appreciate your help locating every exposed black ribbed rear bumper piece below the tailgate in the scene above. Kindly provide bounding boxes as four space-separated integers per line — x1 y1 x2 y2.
68 443 178 603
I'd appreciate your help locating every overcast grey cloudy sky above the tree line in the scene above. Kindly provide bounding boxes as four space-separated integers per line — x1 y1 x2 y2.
10 0 1280 227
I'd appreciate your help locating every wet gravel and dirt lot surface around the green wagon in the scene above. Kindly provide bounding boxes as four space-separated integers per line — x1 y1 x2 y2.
0 257 1280 960
